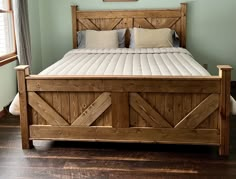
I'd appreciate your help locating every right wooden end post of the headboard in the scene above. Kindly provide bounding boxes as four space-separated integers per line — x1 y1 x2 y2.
180 3 187 48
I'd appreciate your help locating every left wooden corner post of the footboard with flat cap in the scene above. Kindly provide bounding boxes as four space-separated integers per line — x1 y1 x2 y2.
15 65 33 149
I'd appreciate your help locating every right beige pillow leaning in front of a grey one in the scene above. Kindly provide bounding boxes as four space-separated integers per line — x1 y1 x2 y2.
134 28 173 48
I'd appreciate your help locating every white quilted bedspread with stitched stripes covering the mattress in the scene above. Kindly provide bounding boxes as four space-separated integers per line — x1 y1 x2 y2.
10 48 236 115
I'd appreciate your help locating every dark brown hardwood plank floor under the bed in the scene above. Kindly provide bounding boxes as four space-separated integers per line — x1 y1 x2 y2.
0 88 236 179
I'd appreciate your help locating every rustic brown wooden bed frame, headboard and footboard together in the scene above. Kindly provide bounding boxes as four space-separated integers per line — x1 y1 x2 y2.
16 4 231 155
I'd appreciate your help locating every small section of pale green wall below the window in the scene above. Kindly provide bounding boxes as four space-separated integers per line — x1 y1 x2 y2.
0 61 17 111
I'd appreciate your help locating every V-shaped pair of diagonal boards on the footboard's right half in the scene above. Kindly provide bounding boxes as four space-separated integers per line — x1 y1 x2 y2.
130 93 219 129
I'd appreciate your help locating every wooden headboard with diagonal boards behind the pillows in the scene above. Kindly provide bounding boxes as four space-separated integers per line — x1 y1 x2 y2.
71 3 187 48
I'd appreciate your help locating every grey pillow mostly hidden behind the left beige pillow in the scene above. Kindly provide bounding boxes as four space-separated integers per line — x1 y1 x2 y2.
77 29 126 48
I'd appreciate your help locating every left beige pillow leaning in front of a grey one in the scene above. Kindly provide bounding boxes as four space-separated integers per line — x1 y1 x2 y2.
86 30 119 48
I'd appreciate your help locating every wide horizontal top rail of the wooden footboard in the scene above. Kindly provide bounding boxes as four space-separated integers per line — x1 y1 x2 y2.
27 76 220 94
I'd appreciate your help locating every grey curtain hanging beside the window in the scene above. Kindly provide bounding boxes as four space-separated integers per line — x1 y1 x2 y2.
12 0 32 66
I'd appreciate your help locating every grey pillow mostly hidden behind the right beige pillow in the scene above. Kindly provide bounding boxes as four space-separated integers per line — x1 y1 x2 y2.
129 28 180 48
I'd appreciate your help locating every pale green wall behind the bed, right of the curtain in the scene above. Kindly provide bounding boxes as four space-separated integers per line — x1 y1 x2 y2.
29 0 236 80
